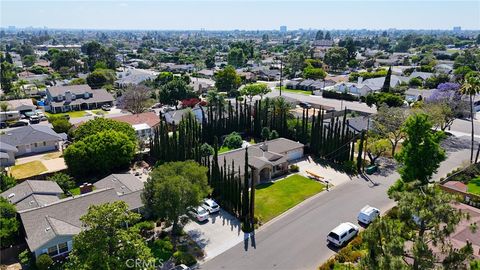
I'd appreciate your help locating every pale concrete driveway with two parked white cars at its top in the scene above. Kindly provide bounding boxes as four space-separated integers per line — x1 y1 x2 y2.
184 209 244 261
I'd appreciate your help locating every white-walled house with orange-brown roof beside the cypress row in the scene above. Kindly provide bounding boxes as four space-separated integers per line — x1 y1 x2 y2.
110 112 160 140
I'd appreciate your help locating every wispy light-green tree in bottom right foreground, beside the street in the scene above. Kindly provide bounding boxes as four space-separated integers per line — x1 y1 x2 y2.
360 187 473 270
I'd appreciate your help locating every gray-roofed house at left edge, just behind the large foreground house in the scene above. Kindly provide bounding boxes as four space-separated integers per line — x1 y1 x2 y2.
0 180 63 211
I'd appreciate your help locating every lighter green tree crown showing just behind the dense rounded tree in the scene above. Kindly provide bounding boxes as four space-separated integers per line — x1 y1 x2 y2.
73 117 137 142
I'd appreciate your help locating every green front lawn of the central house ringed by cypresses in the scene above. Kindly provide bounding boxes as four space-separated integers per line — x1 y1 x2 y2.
255 174 324 223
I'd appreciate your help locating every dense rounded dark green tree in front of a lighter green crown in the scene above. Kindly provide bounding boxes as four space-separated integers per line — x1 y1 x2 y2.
64 130 136 176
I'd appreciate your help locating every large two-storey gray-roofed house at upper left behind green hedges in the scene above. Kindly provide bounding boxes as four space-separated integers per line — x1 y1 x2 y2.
45 84 114 113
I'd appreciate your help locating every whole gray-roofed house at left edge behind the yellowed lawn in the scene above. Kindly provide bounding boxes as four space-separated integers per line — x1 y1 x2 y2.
0 125 65 166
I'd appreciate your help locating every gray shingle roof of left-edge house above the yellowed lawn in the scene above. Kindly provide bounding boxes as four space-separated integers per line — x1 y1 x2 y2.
0 125 62 146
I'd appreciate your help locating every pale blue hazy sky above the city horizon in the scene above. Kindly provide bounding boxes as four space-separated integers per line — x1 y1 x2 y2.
0 0 480 30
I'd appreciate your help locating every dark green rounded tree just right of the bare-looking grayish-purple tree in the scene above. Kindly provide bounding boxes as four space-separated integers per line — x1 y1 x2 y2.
159 77 196 108
